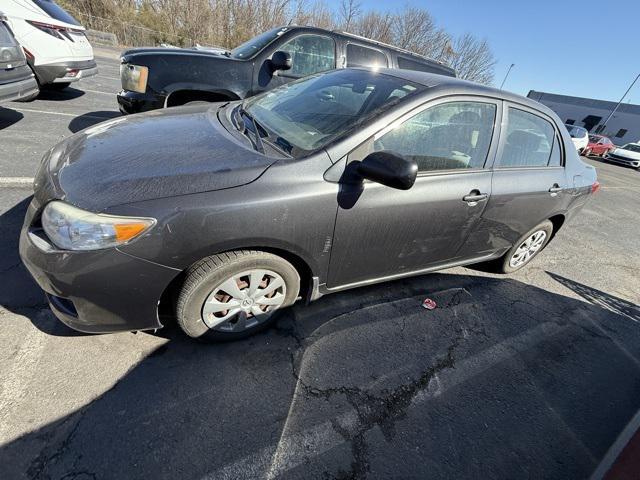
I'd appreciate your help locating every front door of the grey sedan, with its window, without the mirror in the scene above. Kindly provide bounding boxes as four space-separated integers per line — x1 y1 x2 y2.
327 97 500 288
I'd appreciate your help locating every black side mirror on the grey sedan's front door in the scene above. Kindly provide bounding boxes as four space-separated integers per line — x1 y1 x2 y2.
358 151 418 190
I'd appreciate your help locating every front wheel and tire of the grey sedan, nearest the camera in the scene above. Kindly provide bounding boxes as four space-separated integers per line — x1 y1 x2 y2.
176 250 300 341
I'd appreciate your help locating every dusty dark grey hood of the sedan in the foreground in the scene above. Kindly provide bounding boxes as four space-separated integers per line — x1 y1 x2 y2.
35 104 277 212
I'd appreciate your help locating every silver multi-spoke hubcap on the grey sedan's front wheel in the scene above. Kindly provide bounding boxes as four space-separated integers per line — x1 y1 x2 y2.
202 269 287 332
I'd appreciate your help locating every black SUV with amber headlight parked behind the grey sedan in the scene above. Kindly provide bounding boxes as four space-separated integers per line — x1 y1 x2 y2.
118 26 455 113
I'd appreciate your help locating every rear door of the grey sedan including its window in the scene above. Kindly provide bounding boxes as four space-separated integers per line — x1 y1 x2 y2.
467 102 571 252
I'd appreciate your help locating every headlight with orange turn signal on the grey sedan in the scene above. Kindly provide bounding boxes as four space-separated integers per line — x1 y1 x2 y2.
42 201 156 250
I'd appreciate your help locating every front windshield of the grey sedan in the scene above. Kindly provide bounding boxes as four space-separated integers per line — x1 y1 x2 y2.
245 69 424 156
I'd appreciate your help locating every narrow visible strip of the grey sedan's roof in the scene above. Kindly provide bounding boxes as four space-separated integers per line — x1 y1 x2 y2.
369 68 562 118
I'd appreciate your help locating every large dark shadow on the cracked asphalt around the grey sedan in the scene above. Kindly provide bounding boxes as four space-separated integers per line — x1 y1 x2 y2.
0 190 640 479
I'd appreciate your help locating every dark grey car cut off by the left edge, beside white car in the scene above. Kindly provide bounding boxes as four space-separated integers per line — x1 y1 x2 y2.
0 12 39 103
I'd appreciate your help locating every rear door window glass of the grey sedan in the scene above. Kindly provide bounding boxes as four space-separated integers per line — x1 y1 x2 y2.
498 107 560 167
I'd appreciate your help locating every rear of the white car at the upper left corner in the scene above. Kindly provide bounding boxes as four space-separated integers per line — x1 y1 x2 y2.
2 0 98 88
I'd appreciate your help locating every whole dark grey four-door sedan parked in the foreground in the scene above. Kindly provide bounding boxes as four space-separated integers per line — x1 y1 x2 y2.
20 69 599 339
